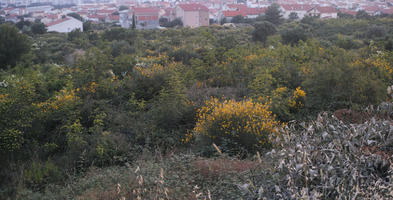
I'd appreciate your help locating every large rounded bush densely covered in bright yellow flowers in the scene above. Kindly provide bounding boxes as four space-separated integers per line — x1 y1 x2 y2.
191 98 281 150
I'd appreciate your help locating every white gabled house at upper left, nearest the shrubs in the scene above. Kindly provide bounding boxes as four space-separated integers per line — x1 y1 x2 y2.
46 17 83 33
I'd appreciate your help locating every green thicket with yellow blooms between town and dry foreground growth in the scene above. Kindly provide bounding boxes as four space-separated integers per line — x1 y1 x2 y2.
0 18 393 199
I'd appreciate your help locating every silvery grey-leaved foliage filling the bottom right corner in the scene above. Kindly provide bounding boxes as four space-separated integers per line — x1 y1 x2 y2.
259 106 393 199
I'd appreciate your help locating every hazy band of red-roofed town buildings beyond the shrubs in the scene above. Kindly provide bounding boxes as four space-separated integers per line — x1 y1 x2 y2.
0 0 393 32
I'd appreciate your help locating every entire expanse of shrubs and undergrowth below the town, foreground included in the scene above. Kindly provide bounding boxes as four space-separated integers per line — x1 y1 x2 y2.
0 17 393 199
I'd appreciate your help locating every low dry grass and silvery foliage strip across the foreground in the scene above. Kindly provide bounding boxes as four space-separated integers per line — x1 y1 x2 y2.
18 108 393 199
